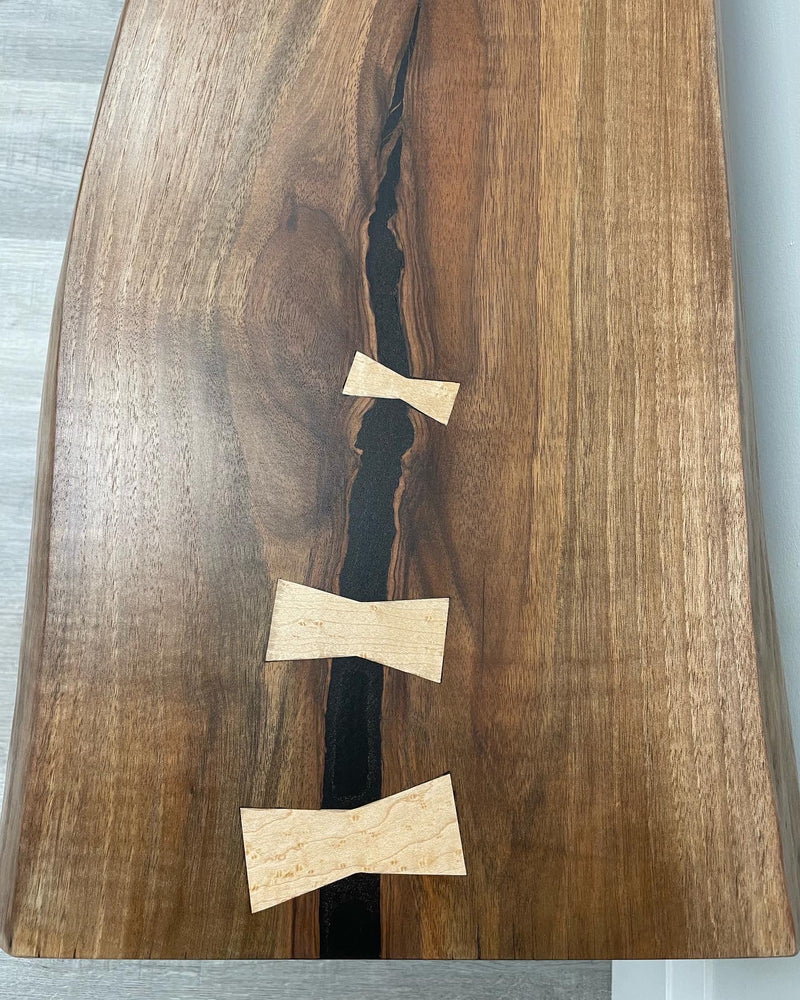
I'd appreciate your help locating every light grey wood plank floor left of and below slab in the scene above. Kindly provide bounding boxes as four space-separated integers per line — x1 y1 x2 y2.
0 0 611 1000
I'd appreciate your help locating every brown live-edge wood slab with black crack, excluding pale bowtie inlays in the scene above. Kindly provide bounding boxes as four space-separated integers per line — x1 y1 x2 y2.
0 0 798 959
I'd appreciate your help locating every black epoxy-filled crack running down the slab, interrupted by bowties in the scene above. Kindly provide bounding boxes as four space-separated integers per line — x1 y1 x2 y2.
319 6 419 958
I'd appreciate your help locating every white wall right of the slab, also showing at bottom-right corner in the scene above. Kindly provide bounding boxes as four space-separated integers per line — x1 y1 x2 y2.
614 0 800 1000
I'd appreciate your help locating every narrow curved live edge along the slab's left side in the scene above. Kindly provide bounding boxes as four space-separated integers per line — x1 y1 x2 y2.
0 0 134 955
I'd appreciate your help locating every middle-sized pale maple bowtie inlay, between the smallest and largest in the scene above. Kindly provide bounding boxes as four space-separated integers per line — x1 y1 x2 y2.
266 580 449 683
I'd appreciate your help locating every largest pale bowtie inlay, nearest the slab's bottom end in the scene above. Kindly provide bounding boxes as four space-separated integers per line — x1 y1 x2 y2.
241 774 467 913
